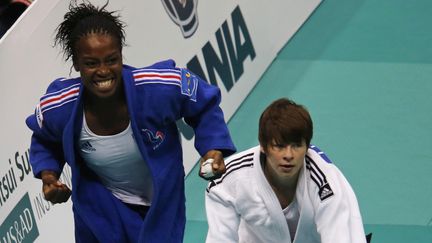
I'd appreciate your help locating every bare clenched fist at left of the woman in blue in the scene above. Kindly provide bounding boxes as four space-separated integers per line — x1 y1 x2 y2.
41 171 72 204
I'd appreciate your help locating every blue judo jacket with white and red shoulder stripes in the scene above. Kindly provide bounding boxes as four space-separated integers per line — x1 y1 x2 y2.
26 60 235 243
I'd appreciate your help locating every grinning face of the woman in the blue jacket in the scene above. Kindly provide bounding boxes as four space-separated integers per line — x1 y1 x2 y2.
74 33 123 98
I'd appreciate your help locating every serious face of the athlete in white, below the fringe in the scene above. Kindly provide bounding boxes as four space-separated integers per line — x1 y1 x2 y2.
261 140 307 180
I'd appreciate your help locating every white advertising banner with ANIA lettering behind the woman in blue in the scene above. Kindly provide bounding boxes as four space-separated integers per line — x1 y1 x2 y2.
0 0 321 242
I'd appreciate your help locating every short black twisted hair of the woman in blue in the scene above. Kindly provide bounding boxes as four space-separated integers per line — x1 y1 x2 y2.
54 0 126 61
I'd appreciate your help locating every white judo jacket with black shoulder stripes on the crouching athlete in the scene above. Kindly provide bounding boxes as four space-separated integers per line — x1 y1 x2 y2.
206 146 366 243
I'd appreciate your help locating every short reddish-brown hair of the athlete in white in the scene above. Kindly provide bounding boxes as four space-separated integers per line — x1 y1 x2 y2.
258 98 313 151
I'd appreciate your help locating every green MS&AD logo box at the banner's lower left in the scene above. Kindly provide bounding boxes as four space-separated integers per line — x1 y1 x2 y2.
0 193 39 243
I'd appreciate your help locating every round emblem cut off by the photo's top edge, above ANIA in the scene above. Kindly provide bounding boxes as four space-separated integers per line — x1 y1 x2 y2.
162 0 198 38
